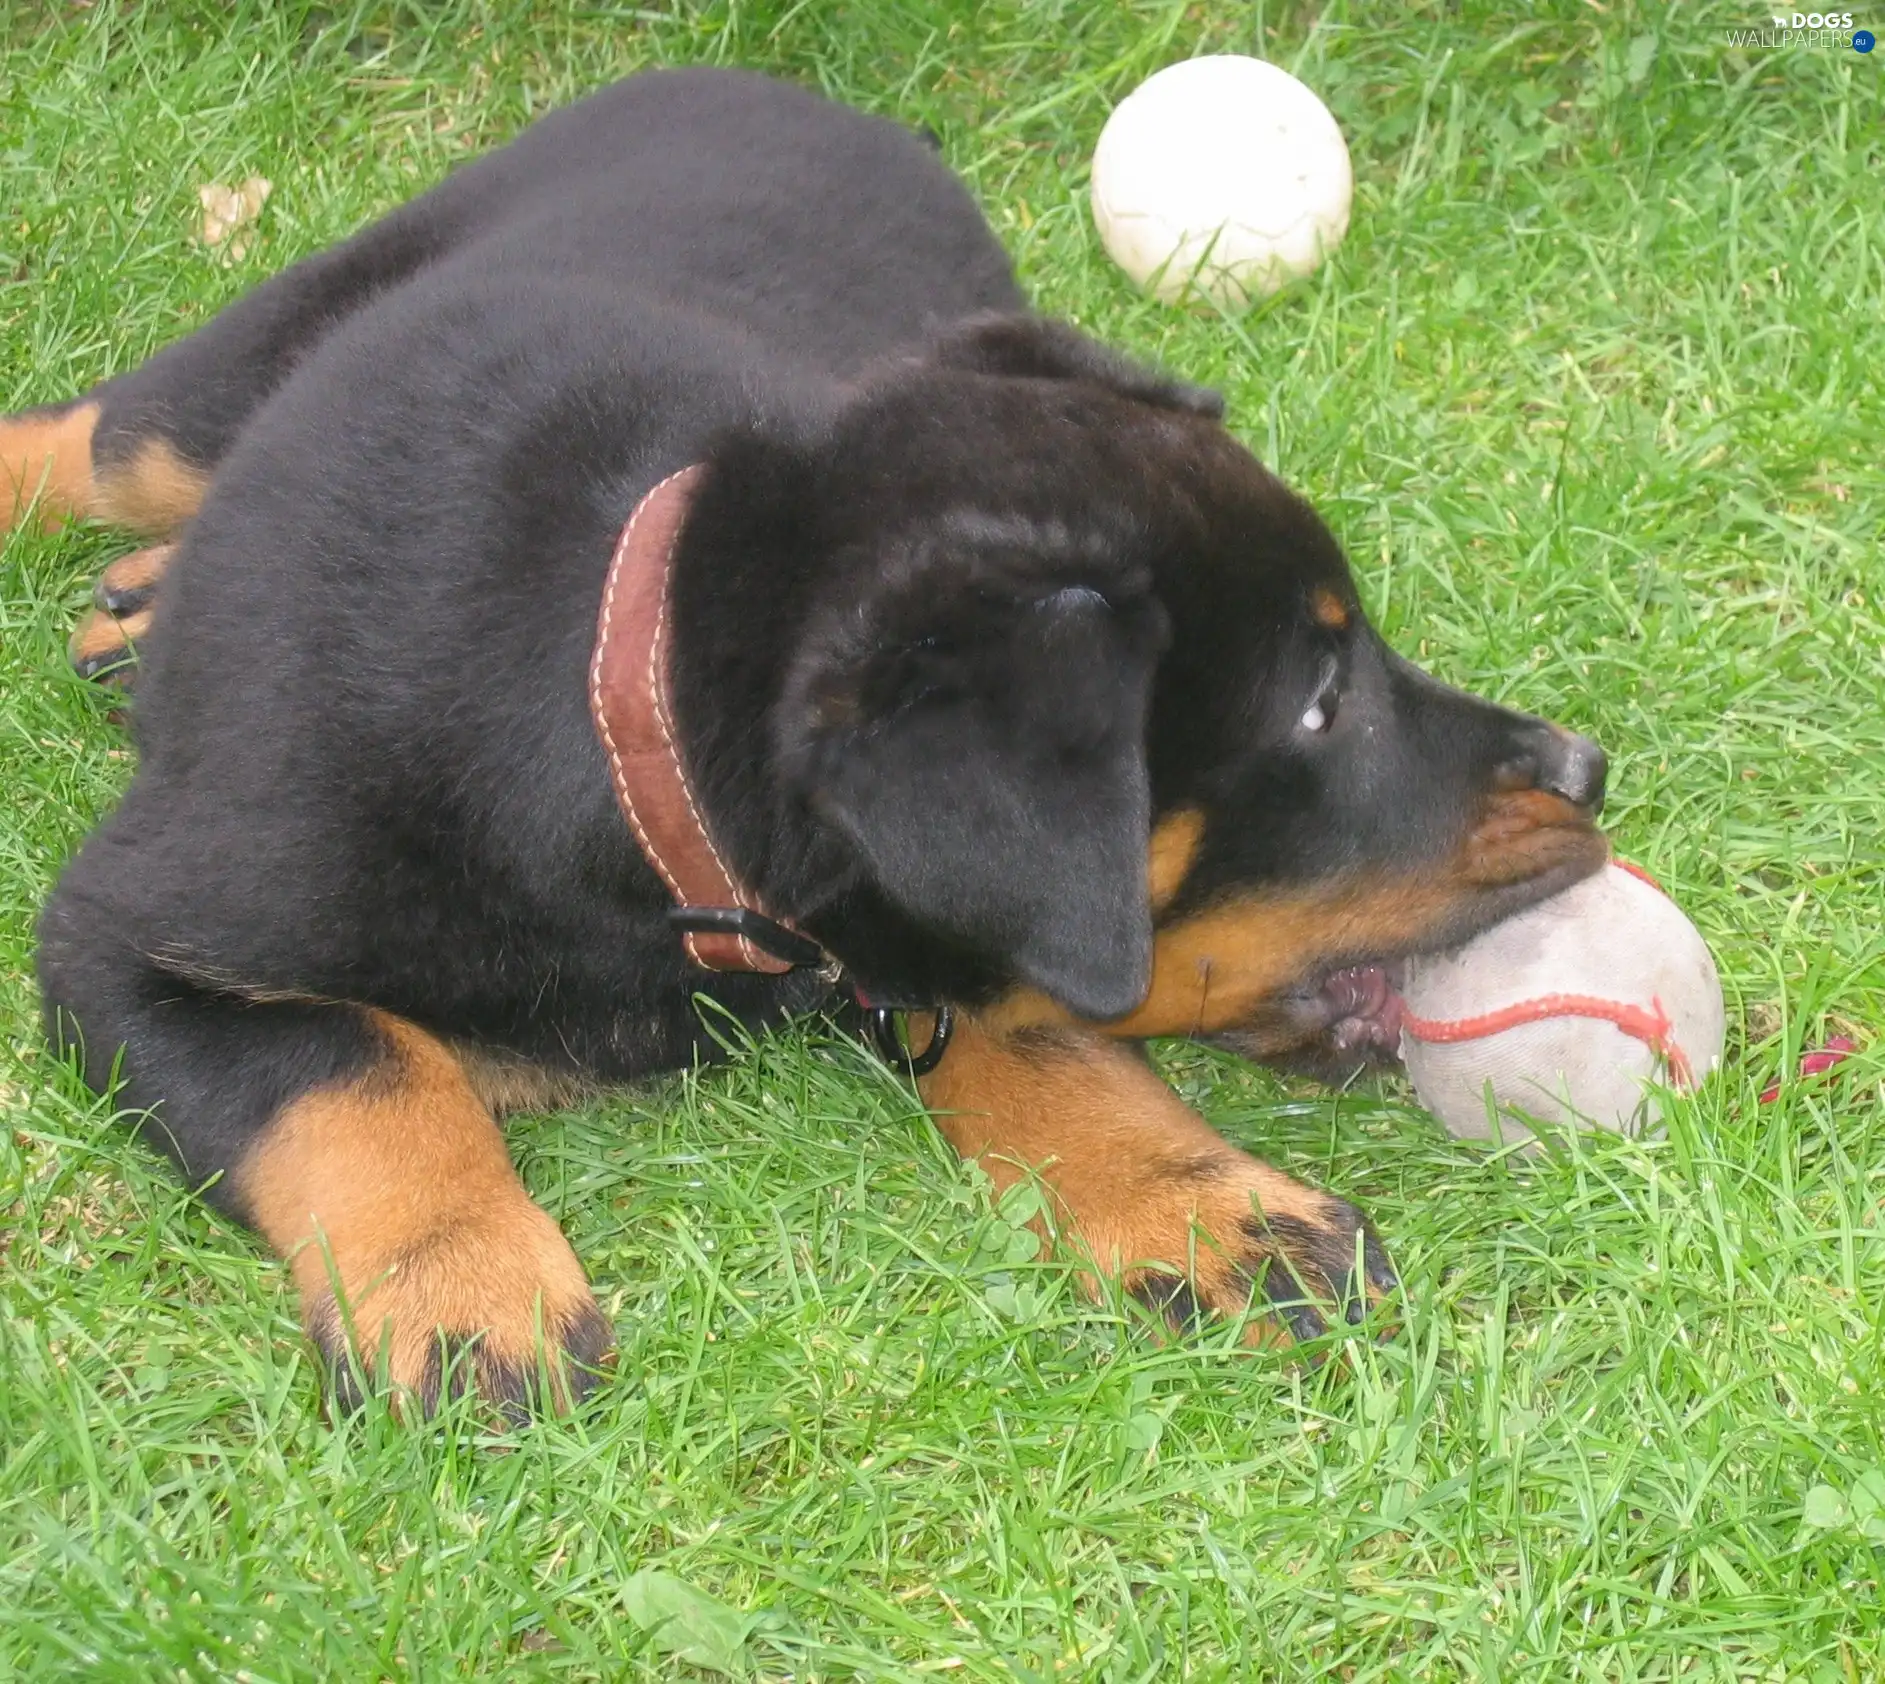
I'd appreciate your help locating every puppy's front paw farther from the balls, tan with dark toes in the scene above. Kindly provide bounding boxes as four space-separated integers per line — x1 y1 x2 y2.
294 1196 613 1420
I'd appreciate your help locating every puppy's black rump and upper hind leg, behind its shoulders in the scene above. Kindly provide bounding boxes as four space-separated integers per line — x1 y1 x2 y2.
96 70 1022 464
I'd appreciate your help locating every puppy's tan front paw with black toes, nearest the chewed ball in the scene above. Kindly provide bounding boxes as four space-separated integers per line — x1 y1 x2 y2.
1123 1148 1397 1345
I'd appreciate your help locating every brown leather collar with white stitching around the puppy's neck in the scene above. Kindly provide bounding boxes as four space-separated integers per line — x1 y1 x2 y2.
590 462 822 975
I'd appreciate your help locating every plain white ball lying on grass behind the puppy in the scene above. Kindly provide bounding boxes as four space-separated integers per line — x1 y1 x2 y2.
1093 53 1355 309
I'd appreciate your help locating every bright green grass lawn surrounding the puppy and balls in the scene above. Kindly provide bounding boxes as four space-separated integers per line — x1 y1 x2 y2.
0 0 1885 1684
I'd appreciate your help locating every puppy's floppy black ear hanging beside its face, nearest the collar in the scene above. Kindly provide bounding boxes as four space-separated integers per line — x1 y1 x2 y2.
780 545 1167 1018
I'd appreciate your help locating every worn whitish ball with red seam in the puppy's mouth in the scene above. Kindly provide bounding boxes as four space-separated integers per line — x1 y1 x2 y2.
1401 864 1727 1141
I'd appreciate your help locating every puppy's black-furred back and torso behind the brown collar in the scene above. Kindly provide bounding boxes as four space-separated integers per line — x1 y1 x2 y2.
73 72 1040 1075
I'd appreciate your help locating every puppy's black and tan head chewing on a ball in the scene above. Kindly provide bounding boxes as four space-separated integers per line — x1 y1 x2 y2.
693 321 1606 1071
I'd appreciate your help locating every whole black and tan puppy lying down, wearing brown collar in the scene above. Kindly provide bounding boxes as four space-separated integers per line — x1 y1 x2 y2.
0 72 1606 1403
